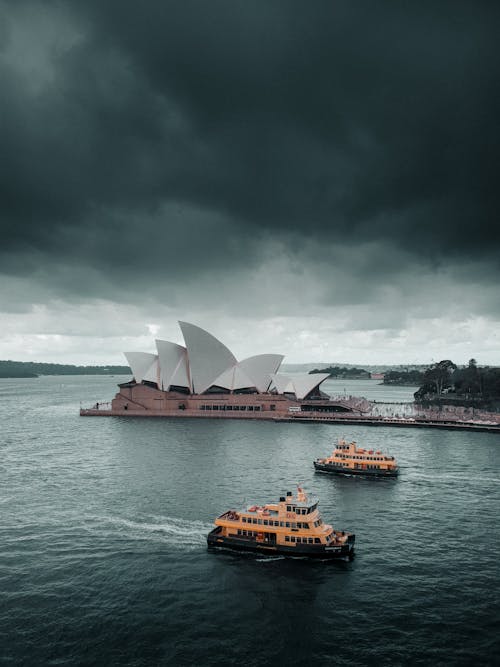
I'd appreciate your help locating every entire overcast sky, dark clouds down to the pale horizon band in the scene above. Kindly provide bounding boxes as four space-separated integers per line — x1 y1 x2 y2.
0 0 500 364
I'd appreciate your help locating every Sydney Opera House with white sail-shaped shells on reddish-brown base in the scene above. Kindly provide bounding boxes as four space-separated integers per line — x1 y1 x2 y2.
82 322 356 419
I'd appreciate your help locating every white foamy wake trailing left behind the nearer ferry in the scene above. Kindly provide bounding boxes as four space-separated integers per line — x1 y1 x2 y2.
94 516 212 551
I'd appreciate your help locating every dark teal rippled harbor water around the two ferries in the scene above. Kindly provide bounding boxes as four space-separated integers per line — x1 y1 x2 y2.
0 376 500 666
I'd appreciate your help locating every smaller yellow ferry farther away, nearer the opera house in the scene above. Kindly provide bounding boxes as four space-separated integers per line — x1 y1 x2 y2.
314 439 399 477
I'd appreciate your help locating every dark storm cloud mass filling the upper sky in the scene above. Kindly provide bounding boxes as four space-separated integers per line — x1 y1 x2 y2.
0 0 500 300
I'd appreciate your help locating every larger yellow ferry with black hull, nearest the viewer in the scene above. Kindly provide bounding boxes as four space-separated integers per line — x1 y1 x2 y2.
207 487 355 560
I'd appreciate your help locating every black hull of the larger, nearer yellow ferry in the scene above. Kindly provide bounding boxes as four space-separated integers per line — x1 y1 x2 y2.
207 528 355 560
